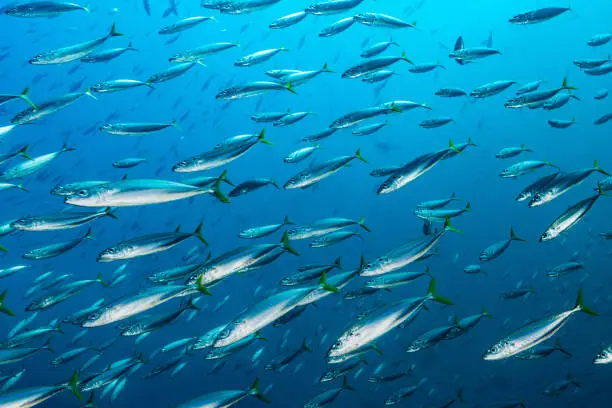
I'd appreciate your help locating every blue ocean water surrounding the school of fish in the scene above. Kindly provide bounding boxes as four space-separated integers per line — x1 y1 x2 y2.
0 0 612 407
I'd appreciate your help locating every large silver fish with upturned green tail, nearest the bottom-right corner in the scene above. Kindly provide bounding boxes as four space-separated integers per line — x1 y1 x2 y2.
482 289 598 361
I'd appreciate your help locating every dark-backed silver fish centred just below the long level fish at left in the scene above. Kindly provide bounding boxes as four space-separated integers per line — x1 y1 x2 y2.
97 223 208 262
